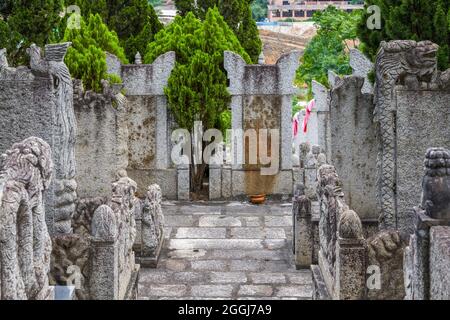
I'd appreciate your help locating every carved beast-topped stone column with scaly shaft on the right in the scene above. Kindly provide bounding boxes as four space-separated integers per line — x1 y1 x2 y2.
375 40 438 229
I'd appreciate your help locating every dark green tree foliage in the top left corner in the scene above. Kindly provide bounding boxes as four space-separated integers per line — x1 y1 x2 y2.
0 0 63 65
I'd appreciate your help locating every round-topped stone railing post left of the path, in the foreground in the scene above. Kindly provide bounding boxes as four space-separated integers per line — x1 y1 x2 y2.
90 205 119 300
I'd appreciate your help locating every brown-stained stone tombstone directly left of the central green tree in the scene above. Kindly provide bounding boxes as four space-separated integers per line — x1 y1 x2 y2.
121 52 177 199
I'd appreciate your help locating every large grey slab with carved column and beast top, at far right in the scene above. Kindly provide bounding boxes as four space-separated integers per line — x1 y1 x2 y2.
375 40 450 232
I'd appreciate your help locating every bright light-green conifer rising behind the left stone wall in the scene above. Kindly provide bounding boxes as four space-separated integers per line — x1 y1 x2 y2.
63 14 128 92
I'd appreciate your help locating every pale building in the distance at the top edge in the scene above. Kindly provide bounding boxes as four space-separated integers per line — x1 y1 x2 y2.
268 0 364 21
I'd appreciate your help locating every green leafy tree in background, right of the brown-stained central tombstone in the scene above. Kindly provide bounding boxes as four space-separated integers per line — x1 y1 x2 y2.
296 6 360 87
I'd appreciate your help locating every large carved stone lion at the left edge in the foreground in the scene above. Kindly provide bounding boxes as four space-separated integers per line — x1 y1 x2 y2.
0 137 53 300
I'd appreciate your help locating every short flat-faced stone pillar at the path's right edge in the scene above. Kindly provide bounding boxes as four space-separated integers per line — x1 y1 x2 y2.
293 195 314 269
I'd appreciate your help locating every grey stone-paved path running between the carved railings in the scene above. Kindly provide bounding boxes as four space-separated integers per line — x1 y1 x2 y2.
139 202 312 300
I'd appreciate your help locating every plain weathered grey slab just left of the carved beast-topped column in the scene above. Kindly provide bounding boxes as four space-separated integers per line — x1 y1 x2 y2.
329 76 378 219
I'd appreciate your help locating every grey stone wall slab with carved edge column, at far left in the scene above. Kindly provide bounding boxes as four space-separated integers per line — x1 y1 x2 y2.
0 43 77 234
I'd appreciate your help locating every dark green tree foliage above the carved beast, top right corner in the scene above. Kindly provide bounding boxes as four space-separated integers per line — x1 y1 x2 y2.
358 0 450 69
